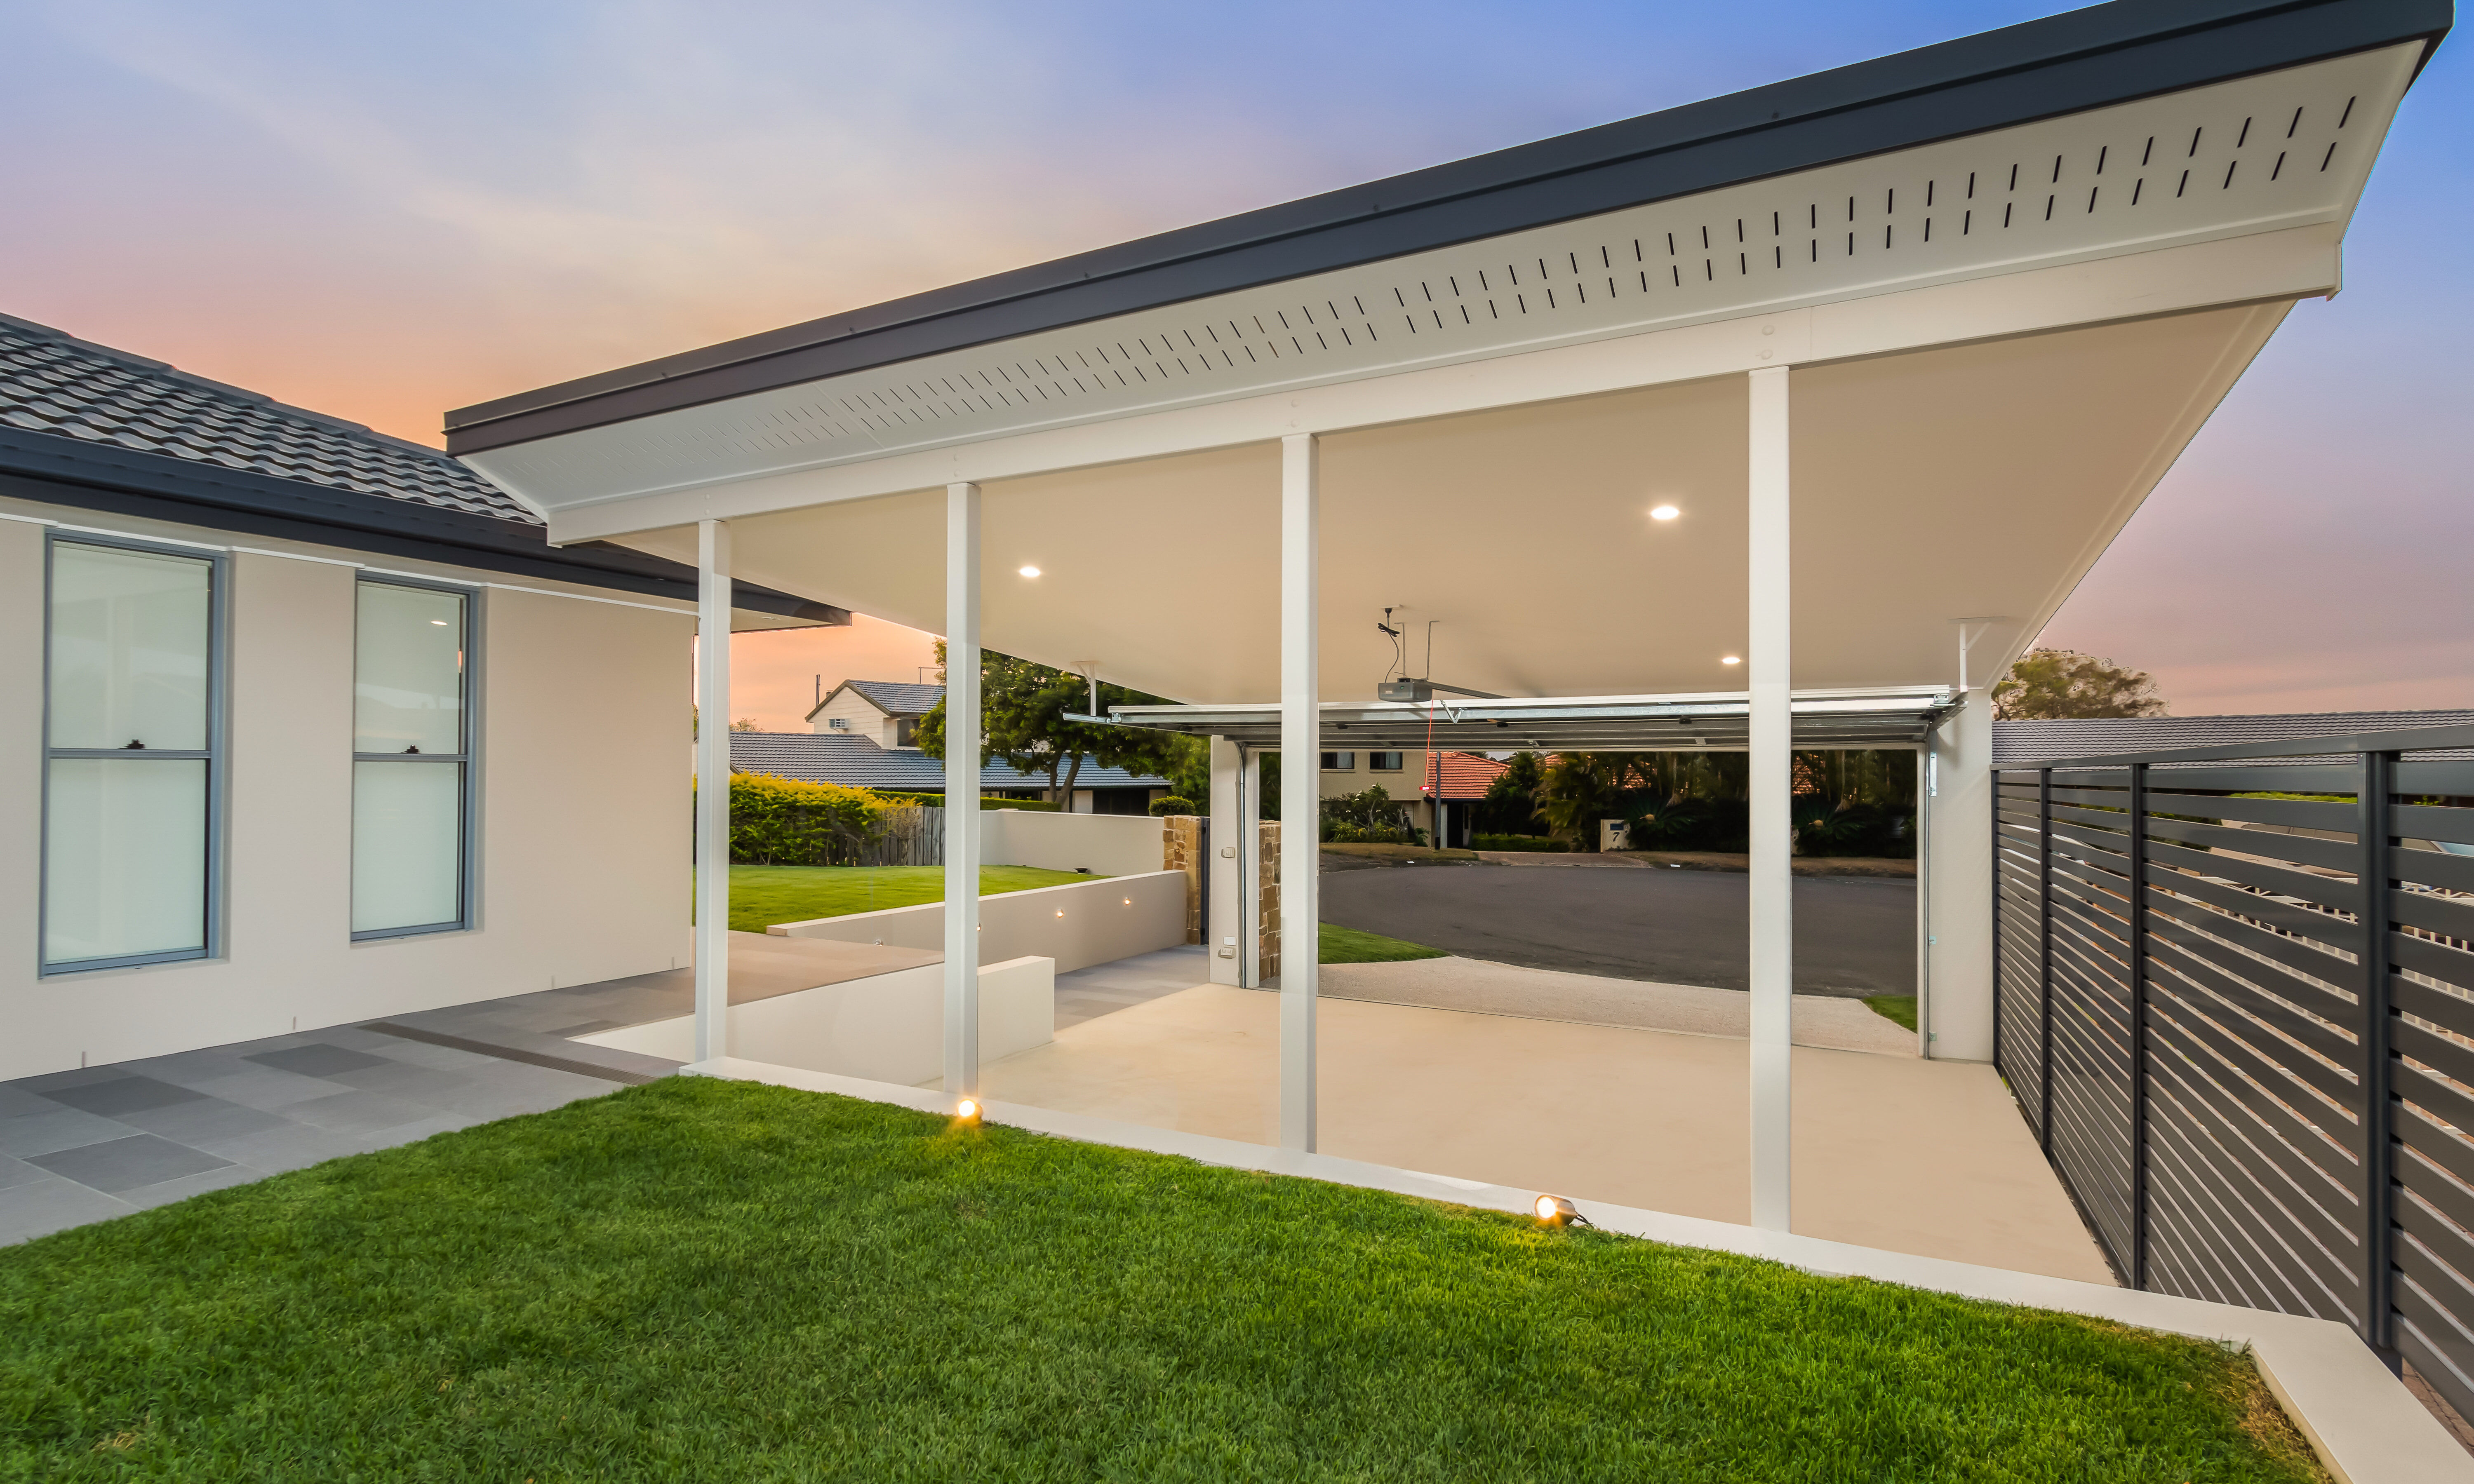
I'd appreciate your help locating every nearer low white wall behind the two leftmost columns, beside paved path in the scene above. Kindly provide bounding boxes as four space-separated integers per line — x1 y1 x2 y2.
574 957 1056 1086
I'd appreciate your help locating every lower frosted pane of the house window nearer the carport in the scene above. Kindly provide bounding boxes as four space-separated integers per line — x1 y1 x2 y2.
351 762 465 932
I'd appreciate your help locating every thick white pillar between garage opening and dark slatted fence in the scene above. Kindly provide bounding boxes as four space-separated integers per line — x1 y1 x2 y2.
1917 690 1994 1061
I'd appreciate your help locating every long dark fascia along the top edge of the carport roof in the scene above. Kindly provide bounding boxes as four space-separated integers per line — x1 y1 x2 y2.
445 0 2454 453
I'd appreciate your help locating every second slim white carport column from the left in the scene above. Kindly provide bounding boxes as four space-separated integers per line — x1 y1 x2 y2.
945 485 980 1098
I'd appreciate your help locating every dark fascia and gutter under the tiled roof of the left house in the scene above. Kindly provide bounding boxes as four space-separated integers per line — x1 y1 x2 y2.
0 428 851 626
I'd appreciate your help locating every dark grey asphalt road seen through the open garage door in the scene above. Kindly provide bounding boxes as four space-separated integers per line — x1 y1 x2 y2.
1321 866 1915 994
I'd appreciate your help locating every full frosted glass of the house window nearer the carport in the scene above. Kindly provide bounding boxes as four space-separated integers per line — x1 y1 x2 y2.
351 581 473 937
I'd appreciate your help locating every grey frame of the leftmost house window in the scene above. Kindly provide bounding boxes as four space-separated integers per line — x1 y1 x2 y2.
35 527 233 979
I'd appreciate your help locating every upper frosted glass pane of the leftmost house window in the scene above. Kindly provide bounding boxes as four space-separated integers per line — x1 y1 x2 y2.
52 542 215 752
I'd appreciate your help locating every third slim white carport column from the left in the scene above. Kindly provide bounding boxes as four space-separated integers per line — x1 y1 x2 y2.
1279 433 1324 1153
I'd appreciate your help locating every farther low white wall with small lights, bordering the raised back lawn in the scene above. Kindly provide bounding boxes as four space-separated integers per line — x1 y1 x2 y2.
767 871 1185 974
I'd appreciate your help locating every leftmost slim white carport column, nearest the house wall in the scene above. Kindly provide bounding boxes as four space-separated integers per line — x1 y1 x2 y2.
695 519 730 1061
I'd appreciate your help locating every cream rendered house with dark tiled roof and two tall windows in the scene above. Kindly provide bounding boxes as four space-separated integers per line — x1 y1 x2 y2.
0 317 849 1078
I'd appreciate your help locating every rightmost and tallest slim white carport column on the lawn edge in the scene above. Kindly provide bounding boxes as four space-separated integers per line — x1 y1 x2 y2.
1744 366 1796 1232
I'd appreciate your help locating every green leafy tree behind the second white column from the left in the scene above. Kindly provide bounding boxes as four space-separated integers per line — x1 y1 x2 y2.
918 638 1197 806
